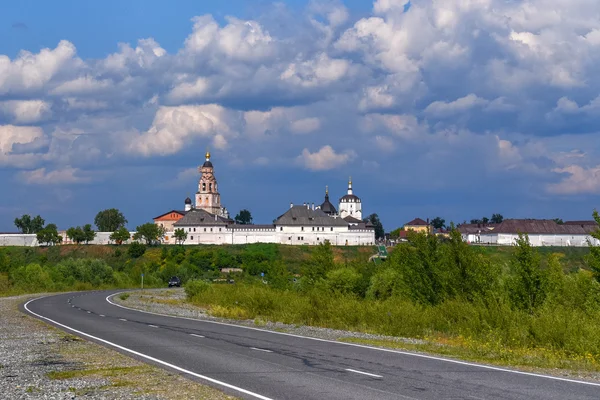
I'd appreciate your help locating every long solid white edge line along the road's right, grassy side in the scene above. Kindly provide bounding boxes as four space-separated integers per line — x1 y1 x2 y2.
105 292 600 387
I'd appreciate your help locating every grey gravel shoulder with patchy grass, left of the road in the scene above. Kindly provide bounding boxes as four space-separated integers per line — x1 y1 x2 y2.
0 295 234 400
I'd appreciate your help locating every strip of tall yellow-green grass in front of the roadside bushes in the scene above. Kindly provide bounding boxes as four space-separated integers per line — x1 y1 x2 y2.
191 285 600 371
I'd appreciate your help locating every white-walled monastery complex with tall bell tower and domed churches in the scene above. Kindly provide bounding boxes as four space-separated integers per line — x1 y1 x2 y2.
154 152 375 246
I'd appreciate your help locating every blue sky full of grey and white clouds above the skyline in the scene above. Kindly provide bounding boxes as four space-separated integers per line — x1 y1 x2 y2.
0 0 600 231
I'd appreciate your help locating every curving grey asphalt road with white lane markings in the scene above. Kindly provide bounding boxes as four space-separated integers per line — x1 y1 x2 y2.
24 291 600 400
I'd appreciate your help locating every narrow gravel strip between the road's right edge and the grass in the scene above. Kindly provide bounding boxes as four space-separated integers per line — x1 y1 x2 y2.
113 289 600 382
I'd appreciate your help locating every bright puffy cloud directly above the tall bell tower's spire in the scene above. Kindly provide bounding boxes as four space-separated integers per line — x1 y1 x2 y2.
128 104 231 156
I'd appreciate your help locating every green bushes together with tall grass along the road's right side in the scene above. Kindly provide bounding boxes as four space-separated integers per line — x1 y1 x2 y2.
179 214 600 371
